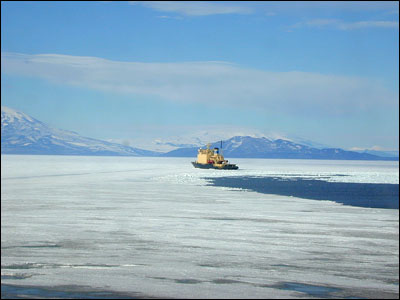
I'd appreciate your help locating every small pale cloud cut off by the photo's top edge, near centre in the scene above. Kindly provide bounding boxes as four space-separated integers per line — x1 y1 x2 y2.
129 1 252 16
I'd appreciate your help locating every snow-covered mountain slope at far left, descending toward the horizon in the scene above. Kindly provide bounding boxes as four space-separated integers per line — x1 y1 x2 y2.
1 106 158 156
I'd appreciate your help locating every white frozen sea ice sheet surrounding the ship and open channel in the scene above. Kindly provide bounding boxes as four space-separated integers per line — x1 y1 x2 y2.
1 155 399 298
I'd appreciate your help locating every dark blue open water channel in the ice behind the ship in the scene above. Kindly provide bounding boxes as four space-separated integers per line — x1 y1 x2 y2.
206 176 399 209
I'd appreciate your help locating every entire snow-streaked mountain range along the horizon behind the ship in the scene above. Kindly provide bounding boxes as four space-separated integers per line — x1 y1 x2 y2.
1 106 398 160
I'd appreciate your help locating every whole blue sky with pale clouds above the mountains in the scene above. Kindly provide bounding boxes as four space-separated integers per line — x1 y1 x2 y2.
1 1 399 150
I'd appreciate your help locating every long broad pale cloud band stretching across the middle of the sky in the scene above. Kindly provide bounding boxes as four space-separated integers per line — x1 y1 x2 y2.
1 53 398 116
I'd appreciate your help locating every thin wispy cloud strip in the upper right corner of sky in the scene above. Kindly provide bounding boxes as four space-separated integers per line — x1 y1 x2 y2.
291 19 399 30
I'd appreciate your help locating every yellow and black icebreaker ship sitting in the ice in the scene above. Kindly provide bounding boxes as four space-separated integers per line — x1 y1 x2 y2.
192 141 239 170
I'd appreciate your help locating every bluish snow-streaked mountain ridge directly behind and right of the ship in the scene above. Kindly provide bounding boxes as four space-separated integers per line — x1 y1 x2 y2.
163 136 390 160
